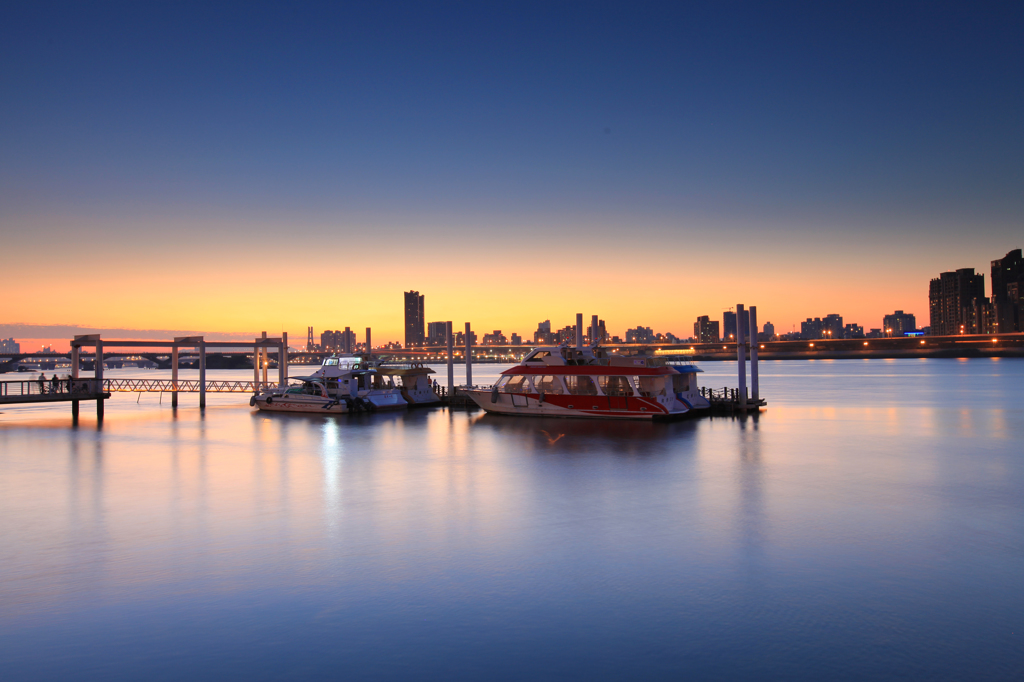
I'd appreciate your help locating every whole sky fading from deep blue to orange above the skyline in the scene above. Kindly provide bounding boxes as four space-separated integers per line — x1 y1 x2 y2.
0 2 1024 345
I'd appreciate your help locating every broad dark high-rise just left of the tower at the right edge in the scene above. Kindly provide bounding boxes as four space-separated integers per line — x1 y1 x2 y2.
928 267 991 336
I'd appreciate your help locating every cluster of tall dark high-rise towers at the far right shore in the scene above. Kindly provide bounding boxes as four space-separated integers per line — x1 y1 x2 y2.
928 249 1024 335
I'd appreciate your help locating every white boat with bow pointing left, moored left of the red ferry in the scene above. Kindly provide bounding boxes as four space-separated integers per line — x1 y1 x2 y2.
249 355 409 413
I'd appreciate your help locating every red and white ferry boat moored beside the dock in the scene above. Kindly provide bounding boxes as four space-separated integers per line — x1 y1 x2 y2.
461 345 711 419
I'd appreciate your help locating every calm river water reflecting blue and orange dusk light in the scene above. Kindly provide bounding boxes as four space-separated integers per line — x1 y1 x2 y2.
0 359 1024 680
